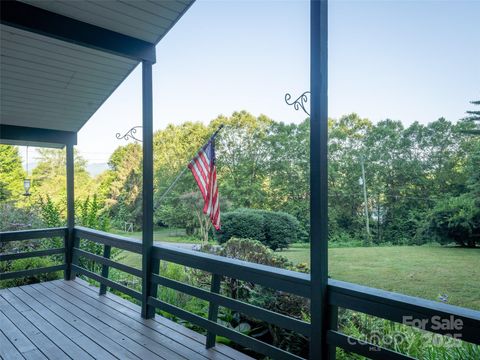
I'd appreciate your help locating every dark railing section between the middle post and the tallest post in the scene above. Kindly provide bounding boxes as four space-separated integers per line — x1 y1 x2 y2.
152 245 310 359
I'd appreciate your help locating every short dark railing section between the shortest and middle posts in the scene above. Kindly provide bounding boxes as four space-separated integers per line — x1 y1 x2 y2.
72 226 143 301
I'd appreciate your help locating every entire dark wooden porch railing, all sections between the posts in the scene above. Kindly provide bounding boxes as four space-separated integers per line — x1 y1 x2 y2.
0 227 480 360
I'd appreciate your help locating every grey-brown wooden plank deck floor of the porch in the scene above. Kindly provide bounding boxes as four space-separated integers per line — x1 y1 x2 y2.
0 279 251 360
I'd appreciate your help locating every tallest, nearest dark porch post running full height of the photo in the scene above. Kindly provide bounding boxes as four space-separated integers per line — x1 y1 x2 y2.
310 0 328 360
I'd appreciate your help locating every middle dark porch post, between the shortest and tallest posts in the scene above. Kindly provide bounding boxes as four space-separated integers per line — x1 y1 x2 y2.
142 60 155 318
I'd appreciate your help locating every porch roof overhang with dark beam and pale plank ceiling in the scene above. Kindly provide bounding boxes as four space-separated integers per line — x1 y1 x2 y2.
0 0 193 145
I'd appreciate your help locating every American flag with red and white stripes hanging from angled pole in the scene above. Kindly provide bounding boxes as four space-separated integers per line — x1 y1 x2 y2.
188 135 220 230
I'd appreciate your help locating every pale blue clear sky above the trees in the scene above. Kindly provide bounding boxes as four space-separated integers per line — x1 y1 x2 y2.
24 0 480 163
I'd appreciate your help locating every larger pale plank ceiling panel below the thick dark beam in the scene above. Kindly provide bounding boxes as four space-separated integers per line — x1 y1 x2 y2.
0 25 138 131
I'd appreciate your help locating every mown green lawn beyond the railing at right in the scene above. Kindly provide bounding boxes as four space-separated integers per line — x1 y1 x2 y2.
280 245 480 310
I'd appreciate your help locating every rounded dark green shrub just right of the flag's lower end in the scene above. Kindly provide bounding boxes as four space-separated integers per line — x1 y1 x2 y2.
216 209 305 250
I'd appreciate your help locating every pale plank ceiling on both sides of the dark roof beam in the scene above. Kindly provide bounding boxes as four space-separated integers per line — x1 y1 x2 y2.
0 0 193 139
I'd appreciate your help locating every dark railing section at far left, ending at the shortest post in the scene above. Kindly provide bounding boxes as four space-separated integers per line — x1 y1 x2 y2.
0 227 67 280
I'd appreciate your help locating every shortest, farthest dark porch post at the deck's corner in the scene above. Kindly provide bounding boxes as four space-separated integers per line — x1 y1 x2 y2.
65 144 75 280
